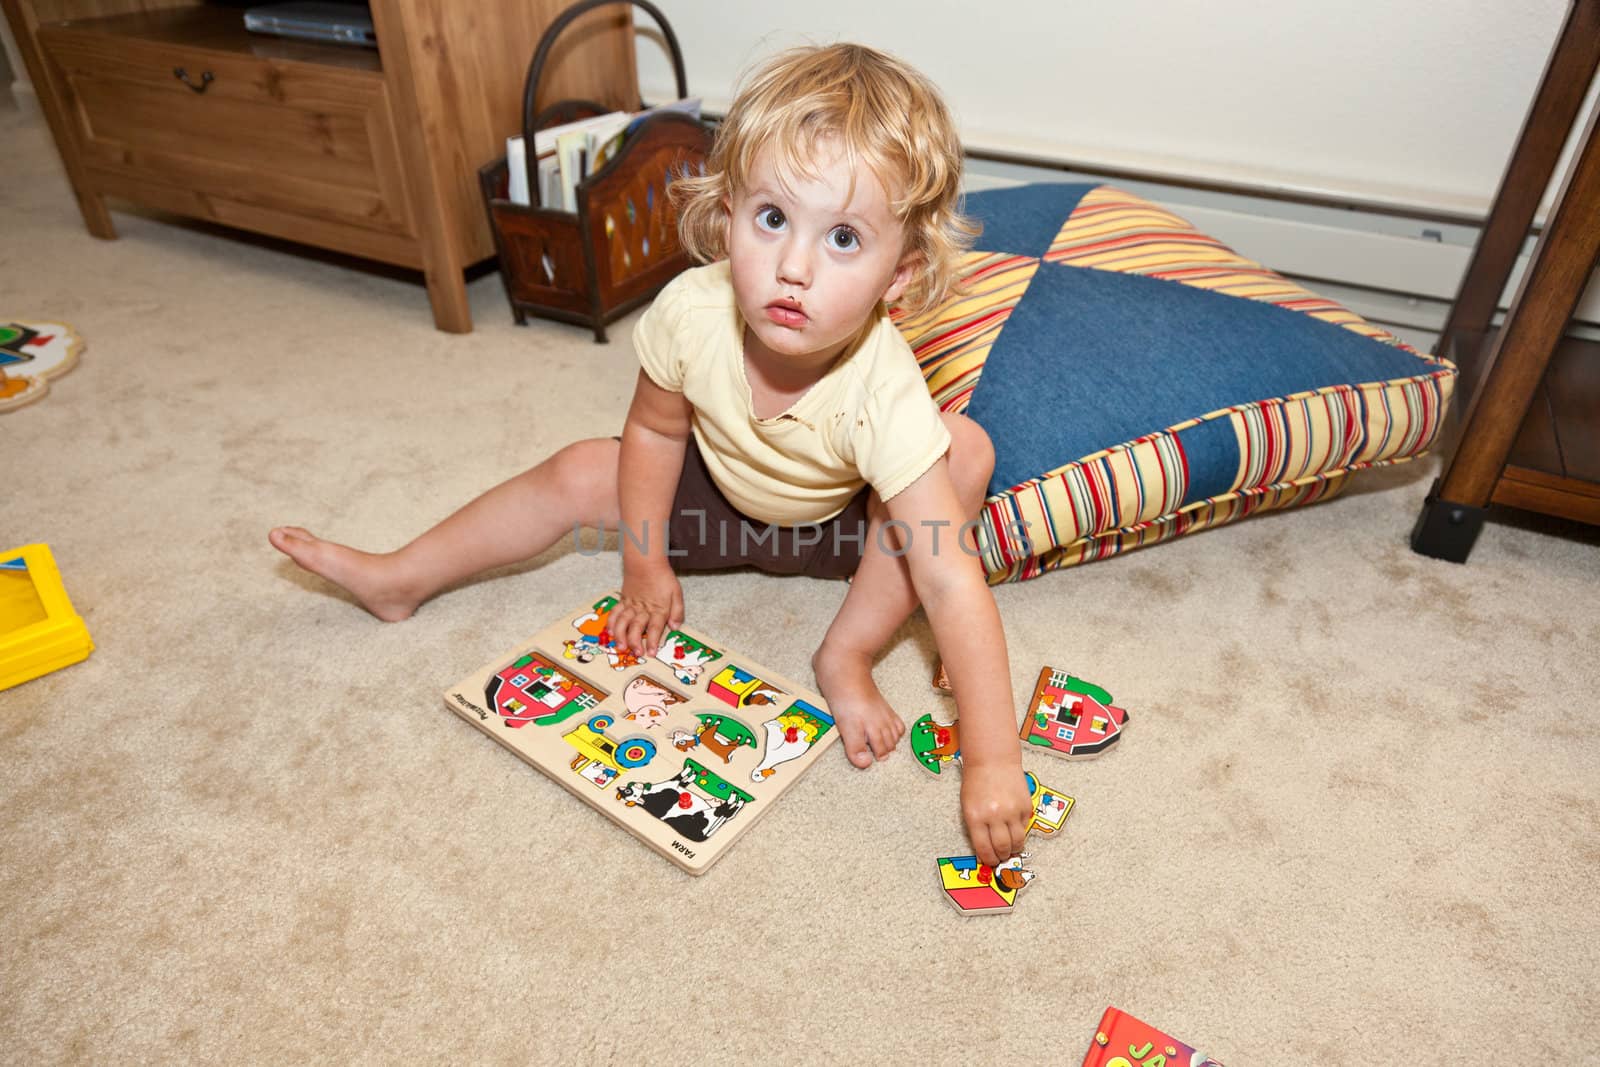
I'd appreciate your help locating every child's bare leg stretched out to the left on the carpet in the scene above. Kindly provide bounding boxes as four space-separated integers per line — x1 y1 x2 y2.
267 438 621 622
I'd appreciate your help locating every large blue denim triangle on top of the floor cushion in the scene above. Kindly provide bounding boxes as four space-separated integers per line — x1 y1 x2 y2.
966 262 1434 499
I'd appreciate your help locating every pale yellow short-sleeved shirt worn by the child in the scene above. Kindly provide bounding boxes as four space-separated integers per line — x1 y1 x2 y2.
634 259 950 526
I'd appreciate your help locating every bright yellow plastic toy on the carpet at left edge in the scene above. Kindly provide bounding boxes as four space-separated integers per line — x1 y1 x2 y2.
0 544 94 689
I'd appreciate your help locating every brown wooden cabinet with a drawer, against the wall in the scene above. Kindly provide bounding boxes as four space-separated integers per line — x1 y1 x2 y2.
0 0 638 333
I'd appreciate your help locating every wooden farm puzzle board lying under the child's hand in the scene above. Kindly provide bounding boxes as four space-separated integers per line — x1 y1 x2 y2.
445 593 838 875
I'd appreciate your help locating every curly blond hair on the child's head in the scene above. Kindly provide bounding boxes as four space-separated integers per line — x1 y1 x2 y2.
672 45 978 315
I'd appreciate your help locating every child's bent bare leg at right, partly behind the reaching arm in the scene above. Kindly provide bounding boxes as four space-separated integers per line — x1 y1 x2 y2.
811 414 995 766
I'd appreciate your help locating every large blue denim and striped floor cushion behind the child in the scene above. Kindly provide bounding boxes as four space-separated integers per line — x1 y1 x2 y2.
896 184 1456 582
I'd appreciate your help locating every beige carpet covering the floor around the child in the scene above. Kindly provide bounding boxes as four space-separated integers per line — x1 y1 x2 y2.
0 102 1600 1067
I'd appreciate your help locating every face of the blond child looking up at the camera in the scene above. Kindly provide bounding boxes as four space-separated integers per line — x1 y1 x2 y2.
728 142 912 366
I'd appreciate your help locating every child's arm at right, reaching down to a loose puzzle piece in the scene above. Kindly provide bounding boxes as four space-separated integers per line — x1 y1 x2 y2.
886 459 1032 865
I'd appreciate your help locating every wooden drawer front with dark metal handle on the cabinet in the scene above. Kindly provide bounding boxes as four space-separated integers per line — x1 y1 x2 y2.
40 26 414 247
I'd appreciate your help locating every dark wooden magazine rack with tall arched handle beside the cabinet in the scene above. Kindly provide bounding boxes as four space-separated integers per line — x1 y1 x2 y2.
478 0 710 341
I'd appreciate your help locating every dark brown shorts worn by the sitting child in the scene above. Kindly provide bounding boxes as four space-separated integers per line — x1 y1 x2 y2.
667 435 872 577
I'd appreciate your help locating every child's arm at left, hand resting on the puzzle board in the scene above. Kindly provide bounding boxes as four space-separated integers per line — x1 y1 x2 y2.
610 371 690 656
